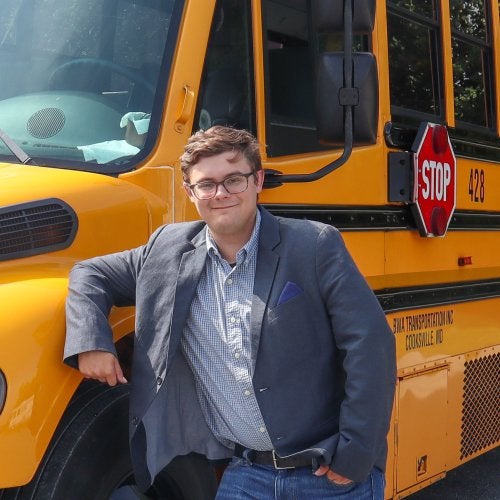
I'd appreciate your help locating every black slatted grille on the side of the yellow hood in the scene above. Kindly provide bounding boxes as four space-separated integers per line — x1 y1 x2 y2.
0 199 78 260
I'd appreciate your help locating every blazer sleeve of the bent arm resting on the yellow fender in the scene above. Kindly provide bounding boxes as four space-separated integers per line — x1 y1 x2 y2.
63 228 162 368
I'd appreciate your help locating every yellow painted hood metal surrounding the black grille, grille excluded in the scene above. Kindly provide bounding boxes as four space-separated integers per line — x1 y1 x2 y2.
0 164 166 266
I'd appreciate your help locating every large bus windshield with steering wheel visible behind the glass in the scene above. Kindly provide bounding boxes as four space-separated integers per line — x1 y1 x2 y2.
0 0 182 172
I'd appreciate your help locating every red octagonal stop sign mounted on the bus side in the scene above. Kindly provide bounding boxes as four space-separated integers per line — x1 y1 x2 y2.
412 123 457 236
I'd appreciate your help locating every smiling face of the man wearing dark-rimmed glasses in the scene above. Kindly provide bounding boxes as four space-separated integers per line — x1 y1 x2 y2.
184 151 264 240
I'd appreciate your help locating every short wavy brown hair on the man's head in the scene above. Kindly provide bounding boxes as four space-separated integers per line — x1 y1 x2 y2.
180 125 262 182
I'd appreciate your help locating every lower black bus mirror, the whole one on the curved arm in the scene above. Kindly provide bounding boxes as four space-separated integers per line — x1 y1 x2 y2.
316 52 378 145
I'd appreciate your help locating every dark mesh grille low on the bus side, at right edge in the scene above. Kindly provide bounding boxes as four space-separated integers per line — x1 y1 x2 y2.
460 353 500 459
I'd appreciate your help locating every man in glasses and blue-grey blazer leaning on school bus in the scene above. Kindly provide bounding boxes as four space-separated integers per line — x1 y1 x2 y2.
65 126 395 500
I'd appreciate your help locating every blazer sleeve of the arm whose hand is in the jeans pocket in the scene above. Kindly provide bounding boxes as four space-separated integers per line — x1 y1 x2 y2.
316 226 396 481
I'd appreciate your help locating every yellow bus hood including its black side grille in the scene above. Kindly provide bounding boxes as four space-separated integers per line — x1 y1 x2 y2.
0 163 161 279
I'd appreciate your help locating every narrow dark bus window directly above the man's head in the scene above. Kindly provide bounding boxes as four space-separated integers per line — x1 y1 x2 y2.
194 0 256 134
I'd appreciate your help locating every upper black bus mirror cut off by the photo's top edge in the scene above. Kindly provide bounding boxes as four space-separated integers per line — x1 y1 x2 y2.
312 0 375 33
